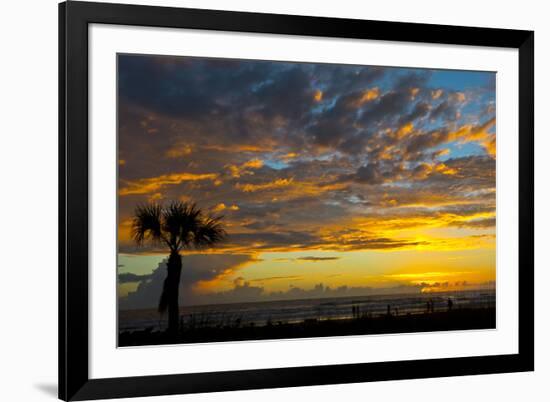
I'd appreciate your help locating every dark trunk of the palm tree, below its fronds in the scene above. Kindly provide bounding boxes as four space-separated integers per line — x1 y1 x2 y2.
159 252 181 334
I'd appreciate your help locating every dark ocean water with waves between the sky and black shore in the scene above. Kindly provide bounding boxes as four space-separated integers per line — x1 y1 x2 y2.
118 289 496 332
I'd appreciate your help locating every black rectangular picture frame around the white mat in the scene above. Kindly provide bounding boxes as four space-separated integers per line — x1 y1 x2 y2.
59 1 534 400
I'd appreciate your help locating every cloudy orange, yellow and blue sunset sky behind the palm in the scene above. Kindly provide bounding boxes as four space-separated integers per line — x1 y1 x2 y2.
118 55 496 308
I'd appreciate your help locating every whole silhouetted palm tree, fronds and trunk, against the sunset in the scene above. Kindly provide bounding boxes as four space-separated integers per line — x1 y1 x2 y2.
132 201 226 334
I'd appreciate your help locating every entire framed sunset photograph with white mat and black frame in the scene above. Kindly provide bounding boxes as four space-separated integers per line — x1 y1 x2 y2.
59 1 534 400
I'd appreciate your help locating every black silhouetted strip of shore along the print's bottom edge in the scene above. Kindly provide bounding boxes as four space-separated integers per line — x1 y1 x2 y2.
118 307 496 347
